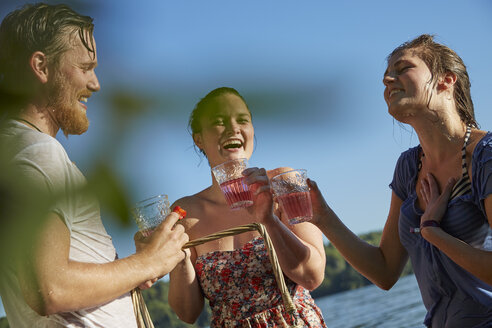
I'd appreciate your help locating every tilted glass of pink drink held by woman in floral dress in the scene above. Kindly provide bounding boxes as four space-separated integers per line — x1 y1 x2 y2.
212 158 253 209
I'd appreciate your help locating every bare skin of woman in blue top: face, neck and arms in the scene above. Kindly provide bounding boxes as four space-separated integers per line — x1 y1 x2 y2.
309 49 492 308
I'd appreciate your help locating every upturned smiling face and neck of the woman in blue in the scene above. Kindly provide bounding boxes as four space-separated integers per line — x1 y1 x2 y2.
383 50 476 195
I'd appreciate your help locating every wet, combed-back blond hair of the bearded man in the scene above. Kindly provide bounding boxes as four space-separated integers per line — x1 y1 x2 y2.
0 3 95 113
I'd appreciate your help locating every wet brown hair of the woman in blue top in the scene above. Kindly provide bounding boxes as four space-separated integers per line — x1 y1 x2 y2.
387 34 478 127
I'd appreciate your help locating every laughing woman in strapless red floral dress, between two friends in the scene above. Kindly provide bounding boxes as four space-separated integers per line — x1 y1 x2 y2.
169 88 325 327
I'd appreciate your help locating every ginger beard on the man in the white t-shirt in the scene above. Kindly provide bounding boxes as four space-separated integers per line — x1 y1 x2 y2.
48 73 89 137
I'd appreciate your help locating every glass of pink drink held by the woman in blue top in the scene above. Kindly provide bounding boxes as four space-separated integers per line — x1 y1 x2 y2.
271 169 313 224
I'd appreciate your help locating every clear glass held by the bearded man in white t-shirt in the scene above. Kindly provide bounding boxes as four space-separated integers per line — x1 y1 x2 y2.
132 195 171 237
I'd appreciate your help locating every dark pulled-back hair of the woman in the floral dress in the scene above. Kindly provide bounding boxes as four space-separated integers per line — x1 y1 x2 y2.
188 87 252 155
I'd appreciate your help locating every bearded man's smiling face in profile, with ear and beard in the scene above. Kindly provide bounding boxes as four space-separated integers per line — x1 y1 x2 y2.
18 32 100 137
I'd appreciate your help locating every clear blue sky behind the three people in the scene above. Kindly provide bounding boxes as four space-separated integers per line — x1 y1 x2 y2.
0 0 492 315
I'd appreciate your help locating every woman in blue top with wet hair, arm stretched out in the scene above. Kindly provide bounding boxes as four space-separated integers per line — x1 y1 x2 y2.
310 35 492 327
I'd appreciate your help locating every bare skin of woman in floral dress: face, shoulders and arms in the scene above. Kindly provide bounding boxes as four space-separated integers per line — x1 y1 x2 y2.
169 94 325 323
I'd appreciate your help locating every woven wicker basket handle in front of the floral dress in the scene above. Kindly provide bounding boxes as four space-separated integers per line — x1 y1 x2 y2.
183 223 297 319
